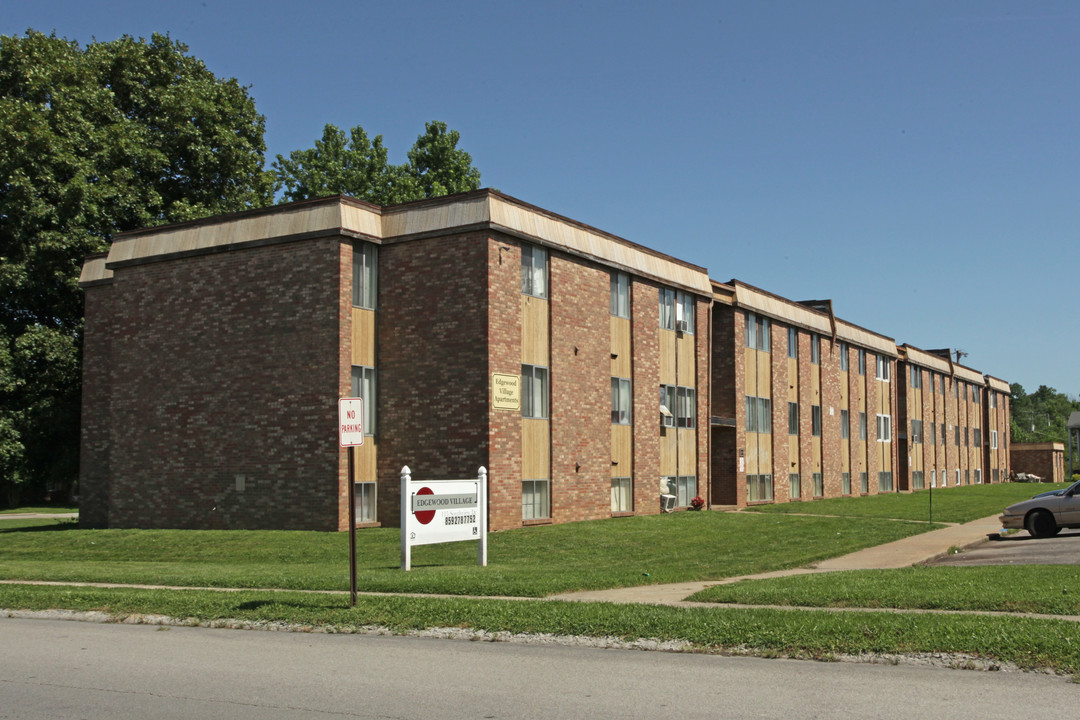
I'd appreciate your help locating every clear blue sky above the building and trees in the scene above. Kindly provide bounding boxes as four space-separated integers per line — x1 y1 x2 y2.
8 0 1080 397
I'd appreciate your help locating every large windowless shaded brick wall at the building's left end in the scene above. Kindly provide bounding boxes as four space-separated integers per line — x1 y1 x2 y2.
98 237 341 530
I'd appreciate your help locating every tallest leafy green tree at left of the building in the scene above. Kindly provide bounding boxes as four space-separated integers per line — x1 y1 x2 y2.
0 30 273 503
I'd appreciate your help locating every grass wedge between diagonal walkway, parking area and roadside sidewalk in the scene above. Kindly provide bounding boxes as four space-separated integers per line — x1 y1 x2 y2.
688 565 1080 617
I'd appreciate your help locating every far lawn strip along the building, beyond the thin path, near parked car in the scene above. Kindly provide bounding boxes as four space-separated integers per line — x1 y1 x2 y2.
747 483 1068 522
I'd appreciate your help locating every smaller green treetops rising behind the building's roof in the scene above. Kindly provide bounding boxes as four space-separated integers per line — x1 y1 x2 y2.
273 120 480 205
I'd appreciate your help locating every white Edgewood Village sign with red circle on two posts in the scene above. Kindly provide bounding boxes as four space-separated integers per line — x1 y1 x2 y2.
401 465 487 571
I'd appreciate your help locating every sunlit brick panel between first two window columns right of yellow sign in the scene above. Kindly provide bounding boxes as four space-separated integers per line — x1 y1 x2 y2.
550 253 613 522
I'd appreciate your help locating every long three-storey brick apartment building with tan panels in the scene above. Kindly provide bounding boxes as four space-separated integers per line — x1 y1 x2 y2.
80 190 1009 530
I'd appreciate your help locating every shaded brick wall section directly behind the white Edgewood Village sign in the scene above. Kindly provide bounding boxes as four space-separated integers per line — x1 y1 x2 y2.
376 233 488 526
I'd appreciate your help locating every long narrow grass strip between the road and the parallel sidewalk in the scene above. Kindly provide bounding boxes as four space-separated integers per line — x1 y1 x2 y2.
0 585 1080 675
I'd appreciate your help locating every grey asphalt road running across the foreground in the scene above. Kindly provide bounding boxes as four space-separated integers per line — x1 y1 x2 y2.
0 617 1077 720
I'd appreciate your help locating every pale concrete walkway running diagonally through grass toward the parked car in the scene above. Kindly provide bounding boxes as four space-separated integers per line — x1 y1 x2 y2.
549 515 1001 606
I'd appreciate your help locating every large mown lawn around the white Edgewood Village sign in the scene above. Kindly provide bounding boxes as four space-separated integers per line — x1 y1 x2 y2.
0 512 929 597
